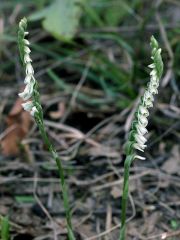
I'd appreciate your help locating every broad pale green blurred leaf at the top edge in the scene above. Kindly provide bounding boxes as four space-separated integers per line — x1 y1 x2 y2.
29 0 86 41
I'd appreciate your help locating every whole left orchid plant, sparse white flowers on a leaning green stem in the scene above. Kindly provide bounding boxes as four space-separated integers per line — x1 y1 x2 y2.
18 18 75 240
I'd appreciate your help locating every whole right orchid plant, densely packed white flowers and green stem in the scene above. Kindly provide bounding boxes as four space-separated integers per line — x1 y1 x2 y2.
119 36 163 240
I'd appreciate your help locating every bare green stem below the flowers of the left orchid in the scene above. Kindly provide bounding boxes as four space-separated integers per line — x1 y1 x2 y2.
35 114 75 240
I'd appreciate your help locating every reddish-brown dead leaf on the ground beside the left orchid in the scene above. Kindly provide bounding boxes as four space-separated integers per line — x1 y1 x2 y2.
0 98 31 156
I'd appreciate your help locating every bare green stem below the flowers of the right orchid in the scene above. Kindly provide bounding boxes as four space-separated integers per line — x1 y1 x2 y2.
119 155 134 240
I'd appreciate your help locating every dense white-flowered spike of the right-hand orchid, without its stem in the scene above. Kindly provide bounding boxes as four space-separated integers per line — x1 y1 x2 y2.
127 36 163 159
